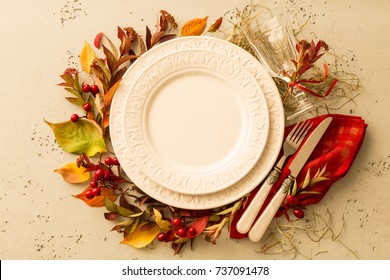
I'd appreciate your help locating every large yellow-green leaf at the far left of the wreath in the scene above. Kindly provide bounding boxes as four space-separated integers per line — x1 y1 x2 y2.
45 119 106 156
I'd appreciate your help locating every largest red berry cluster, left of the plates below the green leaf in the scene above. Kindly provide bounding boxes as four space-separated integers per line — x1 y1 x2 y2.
85 157 120 199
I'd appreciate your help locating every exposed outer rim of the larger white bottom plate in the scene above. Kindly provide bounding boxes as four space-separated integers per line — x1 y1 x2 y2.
110 37 284 209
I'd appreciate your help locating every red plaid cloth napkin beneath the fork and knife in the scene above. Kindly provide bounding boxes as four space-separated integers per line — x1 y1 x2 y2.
230 114 367 238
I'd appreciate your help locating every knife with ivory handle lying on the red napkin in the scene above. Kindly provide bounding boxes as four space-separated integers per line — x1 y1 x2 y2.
248 117 333 242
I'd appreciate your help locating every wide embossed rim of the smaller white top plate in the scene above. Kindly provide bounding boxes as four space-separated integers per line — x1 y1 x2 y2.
123 49 269 195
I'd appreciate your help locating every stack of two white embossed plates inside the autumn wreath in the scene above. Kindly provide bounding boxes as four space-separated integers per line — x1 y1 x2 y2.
110 36 284 209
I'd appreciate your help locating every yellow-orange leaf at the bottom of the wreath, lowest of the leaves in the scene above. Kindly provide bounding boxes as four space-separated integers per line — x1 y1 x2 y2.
121 222 160 248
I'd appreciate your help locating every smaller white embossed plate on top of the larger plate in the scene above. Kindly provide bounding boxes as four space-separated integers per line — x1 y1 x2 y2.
123 48 269 195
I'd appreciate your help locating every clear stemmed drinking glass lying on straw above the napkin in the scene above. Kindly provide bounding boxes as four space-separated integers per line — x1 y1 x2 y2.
242 9 323 120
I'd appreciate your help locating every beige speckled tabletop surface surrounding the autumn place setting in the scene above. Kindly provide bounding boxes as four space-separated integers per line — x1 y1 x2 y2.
0 0 390 259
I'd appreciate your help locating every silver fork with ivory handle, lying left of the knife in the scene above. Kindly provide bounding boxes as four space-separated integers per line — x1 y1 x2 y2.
236 120 313 234
